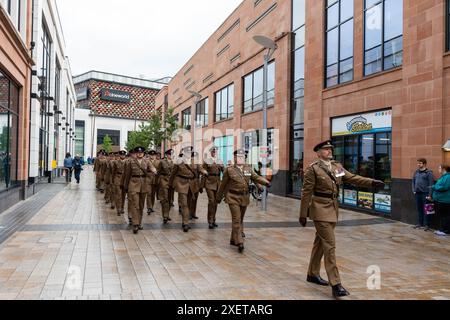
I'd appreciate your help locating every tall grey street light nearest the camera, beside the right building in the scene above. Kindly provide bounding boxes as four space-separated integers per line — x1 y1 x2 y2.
253 36 278 211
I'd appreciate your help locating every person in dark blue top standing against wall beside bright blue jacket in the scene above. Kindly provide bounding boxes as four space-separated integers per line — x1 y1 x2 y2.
412 158 434 231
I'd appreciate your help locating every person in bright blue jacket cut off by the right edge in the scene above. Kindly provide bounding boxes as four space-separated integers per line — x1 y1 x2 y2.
431 164 450 236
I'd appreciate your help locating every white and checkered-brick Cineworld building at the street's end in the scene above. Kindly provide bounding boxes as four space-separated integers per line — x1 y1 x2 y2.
74 71 164 158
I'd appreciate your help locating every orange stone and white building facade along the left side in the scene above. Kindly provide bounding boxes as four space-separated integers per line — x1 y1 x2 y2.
0 0 75 212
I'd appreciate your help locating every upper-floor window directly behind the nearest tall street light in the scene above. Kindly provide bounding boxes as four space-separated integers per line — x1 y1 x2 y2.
244 62 275 113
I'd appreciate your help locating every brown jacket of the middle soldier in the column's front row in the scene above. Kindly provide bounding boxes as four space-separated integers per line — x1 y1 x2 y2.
169 160 204 194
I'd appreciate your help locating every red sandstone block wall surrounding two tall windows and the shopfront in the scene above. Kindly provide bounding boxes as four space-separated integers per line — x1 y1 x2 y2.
305 0 450 179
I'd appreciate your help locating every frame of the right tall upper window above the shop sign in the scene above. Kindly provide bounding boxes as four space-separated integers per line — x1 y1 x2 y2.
363 0 404 77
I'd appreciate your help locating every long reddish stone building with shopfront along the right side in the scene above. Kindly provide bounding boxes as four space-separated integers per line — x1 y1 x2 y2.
161 0 450 223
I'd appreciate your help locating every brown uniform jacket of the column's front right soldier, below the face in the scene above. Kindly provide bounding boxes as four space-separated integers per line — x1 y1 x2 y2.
217 165 269 207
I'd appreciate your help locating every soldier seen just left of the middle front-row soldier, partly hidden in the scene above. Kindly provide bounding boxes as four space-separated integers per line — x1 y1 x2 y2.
157 149 174 224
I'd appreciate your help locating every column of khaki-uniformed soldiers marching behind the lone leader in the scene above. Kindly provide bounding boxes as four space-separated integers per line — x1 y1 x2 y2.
90 146 270 253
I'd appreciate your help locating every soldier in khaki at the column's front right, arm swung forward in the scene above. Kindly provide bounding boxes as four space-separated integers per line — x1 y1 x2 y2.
216 149 270 253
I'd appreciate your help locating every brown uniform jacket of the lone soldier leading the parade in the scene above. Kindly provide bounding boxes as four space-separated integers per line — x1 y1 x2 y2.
300 160 373 223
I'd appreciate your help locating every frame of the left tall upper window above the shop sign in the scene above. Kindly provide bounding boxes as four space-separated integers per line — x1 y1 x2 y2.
324 0 355 89
